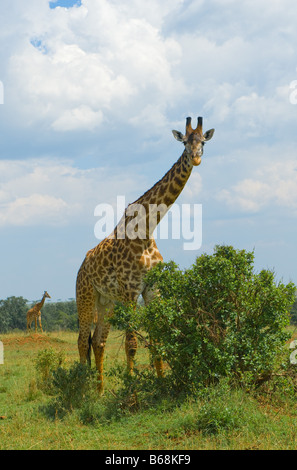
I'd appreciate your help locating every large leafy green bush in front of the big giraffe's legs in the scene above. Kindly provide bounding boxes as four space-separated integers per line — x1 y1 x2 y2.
114 246 295 392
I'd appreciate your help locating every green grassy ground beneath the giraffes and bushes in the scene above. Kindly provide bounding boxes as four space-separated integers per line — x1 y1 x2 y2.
0 332 297 450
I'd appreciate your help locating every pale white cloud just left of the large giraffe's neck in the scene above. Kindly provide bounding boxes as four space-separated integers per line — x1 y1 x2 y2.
0 159 147 227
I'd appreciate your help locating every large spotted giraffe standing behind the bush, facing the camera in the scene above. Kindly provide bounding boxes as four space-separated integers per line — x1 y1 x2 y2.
76 117 214 394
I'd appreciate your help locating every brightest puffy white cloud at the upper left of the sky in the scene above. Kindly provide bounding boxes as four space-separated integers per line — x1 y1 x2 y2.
7 0 183 131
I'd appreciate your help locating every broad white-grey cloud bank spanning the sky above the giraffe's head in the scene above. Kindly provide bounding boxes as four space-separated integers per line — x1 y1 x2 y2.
0 0 297 142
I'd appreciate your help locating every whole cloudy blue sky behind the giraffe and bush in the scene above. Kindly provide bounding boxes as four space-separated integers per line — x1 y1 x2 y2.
0 0 297 301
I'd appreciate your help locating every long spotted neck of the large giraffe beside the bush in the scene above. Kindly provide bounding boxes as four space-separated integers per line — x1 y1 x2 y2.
115 151 193 239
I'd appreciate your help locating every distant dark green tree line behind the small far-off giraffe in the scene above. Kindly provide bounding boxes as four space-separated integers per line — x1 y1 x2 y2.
0 297 78 333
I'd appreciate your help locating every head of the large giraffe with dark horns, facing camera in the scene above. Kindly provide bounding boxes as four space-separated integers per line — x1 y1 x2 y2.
172 117 214 166
